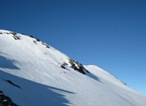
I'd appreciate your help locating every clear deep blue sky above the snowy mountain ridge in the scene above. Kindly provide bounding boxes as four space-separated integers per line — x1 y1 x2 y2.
0 0 146 95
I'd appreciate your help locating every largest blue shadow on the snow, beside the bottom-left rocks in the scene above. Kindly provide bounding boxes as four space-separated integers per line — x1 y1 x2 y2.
0 70 74 106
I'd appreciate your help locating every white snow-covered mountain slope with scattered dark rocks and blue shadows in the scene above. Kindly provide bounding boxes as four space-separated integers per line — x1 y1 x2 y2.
0 30 146 106
